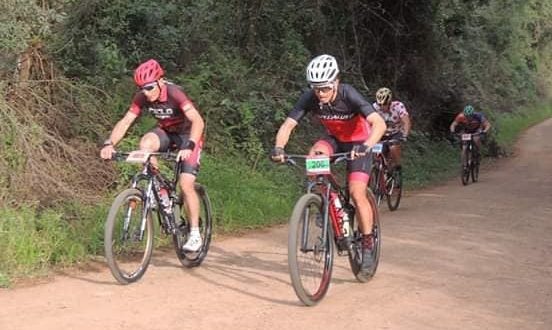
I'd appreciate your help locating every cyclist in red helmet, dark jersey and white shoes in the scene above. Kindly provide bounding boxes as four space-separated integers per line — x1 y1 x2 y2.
100 59 205 251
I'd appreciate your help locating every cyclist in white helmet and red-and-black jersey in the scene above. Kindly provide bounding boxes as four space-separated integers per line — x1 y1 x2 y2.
271 55 385 270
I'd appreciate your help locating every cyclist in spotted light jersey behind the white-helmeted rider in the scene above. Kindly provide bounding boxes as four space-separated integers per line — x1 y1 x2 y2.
373 87 412 170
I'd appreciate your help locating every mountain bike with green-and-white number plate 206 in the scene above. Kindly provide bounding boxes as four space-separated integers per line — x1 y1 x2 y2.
286 153 381 306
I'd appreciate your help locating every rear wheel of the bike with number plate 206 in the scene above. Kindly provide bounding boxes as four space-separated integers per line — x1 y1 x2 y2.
349 190 381 283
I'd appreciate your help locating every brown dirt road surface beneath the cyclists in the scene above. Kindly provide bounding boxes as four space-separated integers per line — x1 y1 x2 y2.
0 120 552 330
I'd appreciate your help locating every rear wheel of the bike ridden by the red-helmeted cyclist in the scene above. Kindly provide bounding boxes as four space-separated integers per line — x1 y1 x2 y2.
173 183 213 268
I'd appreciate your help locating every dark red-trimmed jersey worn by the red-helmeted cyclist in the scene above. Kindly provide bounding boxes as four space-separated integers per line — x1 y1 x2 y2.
130 83 192 134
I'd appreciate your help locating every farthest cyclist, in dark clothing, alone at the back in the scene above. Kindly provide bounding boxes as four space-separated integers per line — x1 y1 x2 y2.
450 104 491 159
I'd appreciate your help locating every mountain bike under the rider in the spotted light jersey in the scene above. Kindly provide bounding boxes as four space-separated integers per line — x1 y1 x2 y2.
368 139 402 211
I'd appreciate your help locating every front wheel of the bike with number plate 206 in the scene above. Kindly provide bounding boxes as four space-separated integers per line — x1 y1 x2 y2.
288 193 334 306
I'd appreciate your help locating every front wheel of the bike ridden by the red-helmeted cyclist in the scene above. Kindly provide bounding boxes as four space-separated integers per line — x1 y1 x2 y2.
104 188 154 284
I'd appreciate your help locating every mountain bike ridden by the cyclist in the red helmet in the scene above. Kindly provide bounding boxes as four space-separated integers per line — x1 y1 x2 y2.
104 151 212 284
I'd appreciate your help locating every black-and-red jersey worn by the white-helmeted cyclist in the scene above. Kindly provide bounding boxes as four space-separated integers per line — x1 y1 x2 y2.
288 84 375 142
